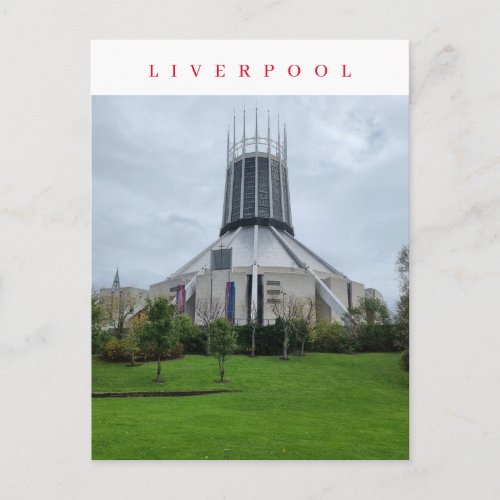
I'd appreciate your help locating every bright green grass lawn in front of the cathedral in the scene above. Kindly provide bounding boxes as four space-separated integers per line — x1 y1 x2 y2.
92 353 408 460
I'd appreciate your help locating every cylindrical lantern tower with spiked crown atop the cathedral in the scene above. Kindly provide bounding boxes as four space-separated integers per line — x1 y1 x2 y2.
220 109 294 236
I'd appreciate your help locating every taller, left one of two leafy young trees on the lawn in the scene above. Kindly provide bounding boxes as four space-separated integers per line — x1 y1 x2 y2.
142 297 178 383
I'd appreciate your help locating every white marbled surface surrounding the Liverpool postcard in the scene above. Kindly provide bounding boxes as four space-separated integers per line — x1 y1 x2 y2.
0 0 500 499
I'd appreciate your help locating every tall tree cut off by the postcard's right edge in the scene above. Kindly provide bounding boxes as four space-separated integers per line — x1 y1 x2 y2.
394 245 410 370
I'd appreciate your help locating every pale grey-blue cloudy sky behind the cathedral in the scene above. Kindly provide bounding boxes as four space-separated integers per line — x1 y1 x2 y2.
92 96 408 307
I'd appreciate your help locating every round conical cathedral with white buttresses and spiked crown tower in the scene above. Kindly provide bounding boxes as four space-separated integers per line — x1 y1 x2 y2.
101 112 383 324
